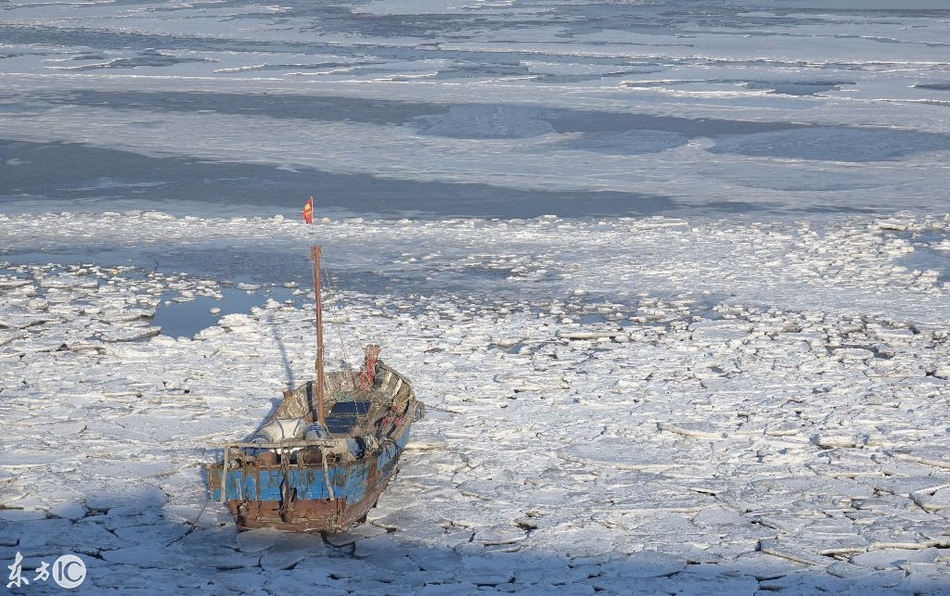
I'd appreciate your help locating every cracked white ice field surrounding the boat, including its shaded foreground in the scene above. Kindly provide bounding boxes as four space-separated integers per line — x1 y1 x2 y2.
0 211 950 594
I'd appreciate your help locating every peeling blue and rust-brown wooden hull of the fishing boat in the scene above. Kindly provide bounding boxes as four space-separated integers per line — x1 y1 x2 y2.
206 365 424 533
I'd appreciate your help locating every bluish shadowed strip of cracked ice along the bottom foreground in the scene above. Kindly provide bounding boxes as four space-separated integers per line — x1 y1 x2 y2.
0 485 950 595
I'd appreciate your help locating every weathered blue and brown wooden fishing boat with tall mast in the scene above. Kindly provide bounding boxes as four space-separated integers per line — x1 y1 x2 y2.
205 246 425 533
